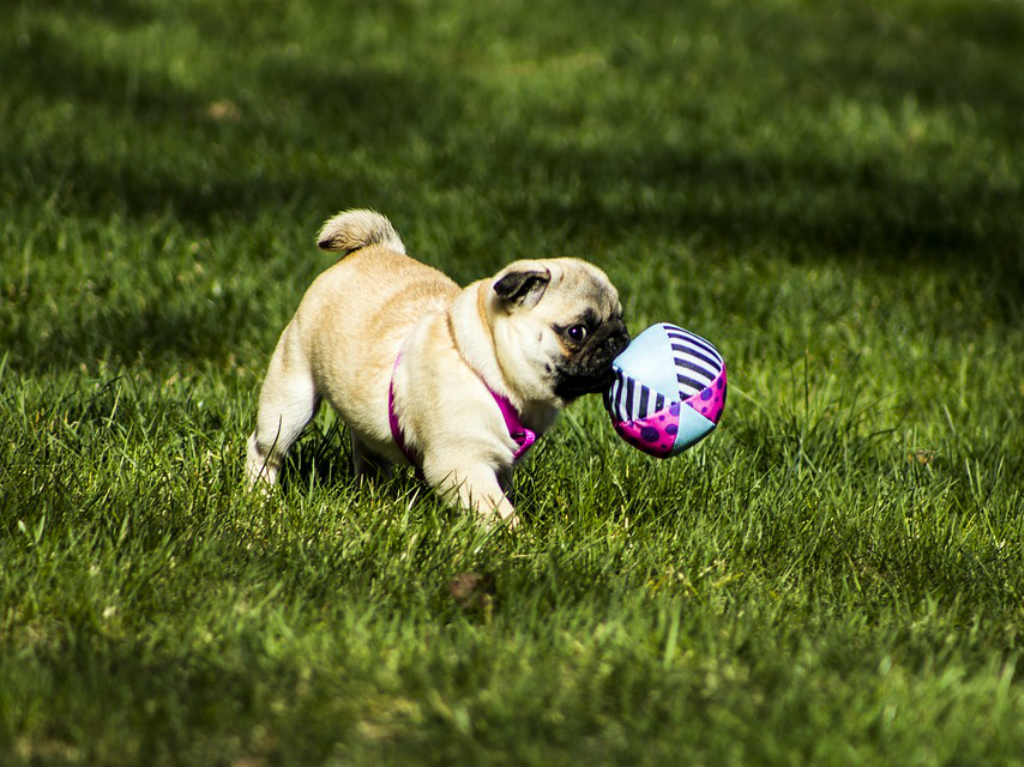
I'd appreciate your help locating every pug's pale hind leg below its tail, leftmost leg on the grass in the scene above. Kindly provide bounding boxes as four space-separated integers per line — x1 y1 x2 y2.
246 324 319 486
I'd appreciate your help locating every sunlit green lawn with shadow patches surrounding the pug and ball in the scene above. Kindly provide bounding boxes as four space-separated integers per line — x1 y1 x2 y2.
0 0 1024 764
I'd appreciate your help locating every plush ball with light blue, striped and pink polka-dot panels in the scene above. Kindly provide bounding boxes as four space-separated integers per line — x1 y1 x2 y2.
604 323 726 458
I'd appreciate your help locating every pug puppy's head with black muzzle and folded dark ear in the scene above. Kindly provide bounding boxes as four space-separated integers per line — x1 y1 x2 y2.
489 258 630 407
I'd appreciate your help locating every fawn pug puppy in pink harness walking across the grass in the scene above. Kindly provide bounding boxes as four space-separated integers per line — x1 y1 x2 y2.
247 210 630 526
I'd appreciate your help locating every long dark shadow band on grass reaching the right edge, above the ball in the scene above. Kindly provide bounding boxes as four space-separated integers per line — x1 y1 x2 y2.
487 137 1024 266
